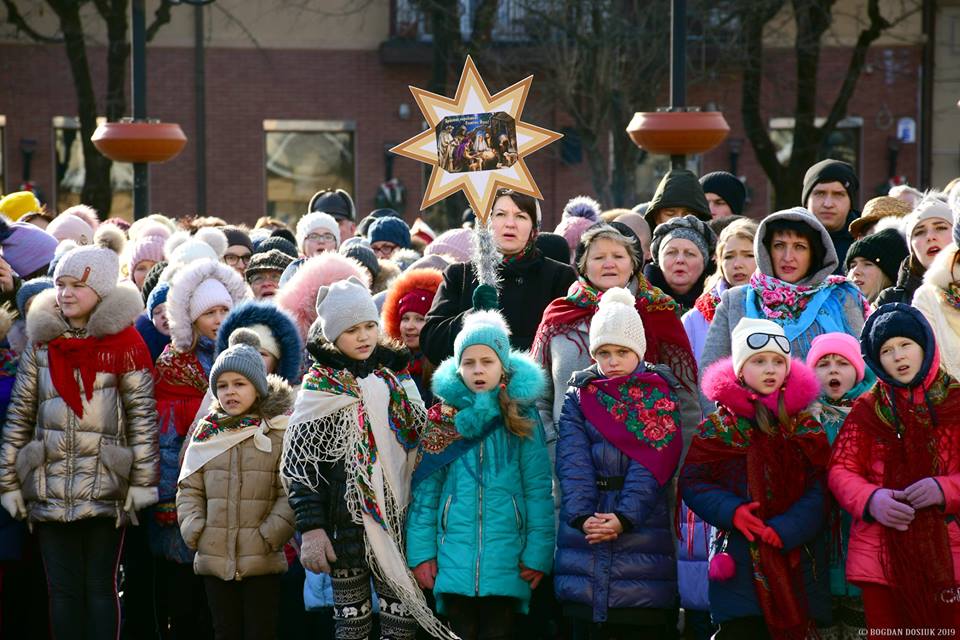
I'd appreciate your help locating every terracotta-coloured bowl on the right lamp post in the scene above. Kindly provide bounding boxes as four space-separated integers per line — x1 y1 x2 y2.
627 111 730 156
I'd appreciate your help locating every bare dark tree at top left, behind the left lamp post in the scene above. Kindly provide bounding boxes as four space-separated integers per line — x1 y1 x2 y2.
2 0 171 215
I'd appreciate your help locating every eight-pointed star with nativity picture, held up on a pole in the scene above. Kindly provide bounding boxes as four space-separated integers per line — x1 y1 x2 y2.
391 56 562 223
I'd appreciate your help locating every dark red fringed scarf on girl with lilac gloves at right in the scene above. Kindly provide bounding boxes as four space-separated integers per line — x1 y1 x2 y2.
832 370 960 628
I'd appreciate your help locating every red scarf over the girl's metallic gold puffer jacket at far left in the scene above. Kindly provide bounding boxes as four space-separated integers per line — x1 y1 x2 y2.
47 326 153 418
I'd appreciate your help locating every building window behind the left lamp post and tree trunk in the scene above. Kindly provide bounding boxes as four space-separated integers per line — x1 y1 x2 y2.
53 116 133 220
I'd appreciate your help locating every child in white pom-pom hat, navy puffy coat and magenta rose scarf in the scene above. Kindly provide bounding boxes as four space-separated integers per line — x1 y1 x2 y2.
554 287 683 638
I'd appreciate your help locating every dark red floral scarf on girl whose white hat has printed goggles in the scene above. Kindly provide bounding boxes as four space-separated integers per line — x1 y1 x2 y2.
681 405 830 640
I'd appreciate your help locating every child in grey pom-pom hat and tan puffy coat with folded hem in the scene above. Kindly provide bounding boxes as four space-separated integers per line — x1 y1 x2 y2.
177 329 293 638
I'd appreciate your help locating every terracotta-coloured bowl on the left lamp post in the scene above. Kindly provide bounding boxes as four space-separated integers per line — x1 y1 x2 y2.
91 122 187 163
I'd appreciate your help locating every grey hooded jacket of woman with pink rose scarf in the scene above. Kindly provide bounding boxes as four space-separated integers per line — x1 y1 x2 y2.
700 210 864 413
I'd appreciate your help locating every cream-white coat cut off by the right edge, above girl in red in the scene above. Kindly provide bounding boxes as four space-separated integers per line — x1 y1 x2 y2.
913 244 960 379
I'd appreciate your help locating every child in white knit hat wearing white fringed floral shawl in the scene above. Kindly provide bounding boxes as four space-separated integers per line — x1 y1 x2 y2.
281 276 444 639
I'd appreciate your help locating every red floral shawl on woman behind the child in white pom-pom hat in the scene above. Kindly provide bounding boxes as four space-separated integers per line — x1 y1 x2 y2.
531 275 684 377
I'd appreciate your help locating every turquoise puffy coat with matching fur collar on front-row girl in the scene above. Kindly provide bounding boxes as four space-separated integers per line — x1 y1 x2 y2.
407 353 555 613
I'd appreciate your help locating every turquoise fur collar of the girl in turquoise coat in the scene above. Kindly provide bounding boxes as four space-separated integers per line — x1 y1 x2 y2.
431 351 547 438
